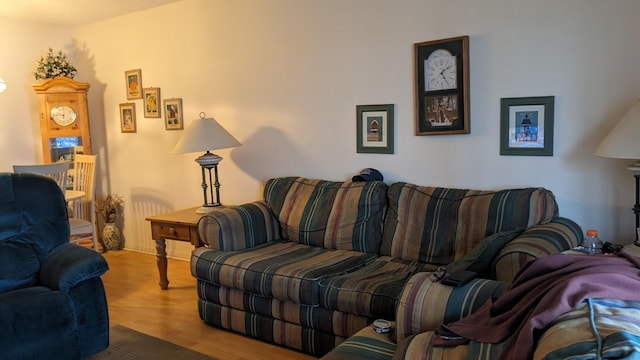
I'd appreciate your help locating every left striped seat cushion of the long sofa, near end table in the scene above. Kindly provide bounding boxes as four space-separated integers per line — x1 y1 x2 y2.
191 241 376 305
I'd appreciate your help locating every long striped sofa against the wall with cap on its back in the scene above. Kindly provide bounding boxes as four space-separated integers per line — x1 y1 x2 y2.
191 177 582 356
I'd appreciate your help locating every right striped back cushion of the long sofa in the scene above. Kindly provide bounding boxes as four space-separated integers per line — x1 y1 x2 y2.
380 182 558 265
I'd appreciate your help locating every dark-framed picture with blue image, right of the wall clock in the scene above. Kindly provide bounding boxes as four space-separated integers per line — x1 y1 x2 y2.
500 96 555 156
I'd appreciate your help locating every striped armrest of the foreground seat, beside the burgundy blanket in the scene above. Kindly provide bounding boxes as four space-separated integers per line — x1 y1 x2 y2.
396 272 508 342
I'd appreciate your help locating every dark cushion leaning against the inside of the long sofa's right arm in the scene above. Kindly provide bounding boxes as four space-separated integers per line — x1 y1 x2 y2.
446 229 522 279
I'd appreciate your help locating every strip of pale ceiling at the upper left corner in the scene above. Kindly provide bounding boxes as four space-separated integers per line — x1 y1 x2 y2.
0 0 179 26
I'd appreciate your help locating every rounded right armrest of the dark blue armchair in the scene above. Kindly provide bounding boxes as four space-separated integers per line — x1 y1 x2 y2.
40 243 109 292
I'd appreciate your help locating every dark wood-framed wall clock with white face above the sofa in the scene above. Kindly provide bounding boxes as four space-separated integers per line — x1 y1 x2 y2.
414 36 471 135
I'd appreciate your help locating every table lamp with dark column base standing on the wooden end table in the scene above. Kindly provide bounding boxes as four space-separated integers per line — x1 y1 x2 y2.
173 113 241 214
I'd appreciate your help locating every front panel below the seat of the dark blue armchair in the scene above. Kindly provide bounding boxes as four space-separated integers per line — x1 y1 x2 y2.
0 286 75 348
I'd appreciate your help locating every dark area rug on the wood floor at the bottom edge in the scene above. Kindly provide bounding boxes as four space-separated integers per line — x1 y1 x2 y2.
85 325 215 360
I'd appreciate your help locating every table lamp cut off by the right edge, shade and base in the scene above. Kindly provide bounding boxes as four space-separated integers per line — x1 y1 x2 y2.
593 101 640 246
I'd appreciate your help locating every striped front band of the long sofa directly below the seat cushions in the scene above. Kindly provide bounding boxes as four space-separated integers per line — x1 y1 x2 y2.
197 280 368 338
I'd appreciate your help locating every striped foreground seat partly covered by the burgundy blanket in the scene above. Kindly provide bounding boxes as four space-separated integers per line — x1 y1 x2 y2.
322 256 640 360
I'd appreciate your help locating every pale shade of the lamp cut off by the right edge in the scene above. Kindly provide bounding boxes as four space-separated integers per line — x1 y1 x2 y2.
593 101 640 159
